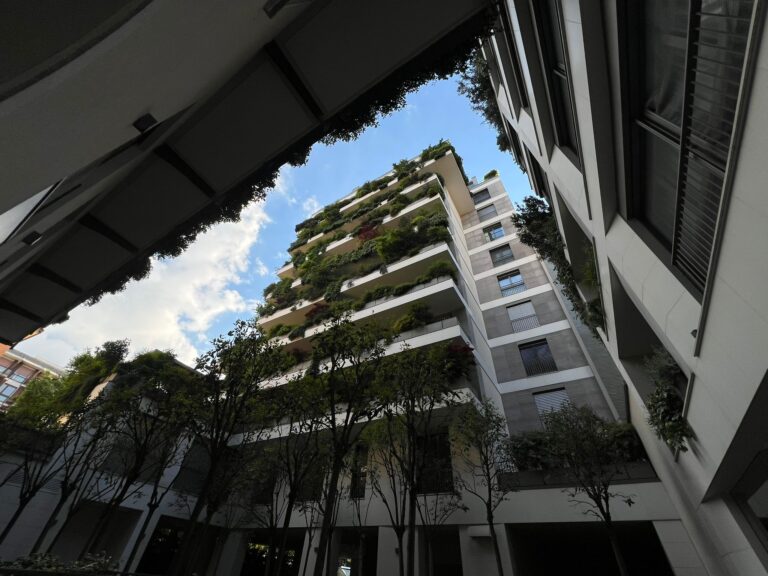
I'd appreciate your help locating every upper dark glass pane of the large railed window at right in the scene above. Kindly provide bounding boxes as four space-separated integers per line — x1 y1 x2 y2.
638 0 688 128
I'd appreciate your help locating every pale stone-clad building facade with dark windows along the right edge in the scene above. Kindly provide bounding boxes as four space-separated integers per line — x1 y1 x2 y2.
484 0 768 576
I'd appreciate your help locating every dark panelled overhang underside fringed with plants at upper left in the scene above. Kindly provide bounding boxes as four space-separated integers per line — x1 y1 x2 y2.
0 0 487 343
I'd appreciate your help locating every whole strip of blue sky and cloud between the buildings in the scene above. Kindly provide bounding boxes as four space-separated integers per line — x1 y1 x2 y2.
19 79 530 366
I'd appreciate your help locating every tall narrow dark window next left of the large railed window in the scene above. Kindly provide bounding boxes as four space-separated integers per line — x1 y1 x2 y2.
534 0 579 164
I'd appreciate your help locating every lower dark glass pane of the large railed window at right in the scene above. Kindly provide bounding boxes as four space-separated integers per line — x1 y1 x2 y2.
636 128 679 249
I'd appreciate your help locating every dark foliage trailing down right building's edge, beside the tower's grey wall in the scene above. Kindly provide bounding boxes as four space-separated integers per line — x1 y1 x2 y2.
512 196 604 335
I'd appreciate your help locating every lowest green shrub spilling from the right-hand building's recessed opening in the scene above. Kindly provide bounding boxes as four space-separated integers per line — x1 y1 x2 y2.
645 348 694 452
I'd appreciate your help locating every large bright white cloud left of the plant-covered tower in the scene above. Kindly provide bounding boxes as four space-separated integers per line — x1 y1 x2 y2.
19 184 276 365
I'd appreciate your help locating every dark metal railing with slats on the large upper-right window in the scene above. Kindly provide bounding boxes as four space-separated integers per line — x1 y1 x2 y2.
672 0 755 293
